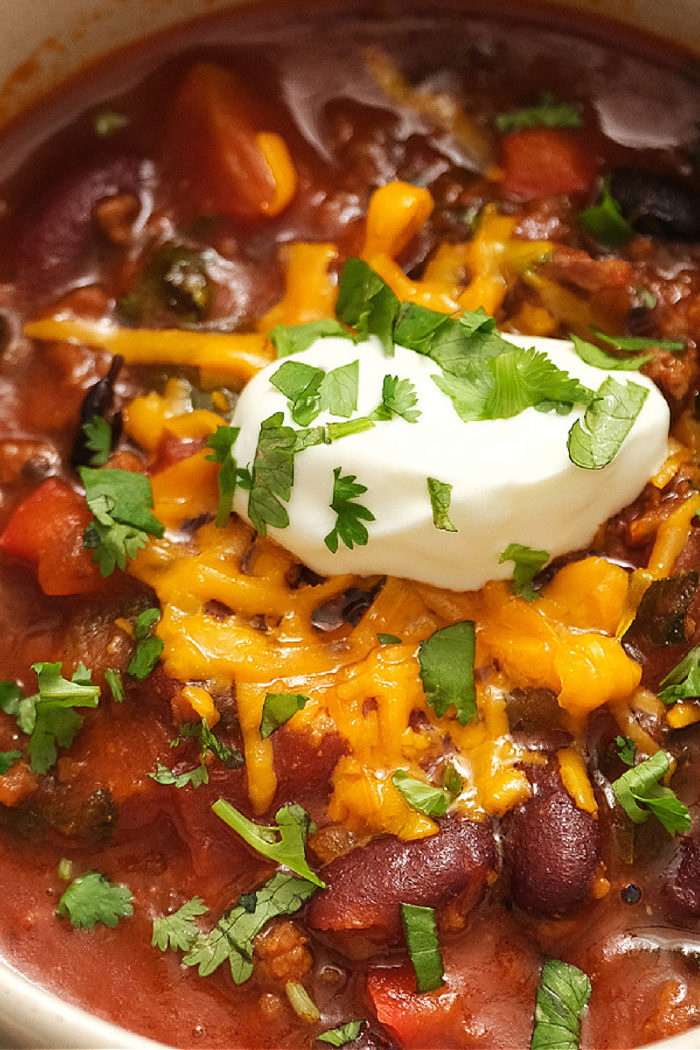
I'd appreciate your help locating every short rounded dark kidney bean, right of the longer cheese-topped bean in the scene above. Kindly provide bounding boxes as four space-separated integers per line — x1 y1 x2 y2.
505 783 599 915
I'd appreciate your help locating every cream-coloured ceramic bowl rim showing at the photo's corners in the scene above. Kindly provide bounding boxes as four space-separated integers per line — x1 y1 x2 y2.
0 0 700 1050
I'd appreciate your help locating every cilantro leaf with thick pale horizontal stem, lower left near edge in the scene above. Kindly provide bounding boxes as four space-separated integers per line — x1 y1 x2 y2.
17 663 100 774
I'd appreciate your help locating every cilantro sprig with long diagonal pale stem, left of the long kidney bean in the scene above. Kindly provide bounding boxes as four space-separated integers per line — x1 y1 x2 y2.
212 798 325 886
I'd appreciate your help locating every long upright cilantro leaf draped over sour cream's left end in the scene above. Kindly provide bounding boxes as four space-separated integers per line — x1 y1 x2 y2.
248 412 297 536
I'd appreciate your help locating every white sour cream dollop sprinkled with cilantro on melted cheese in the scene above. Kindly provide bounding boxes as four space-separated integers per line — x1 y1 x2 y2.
232 336 670 590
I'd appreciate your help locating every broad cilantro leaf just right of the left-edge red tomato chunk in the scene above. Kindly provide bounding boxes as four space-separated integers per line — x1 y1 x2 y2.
79 466 165 576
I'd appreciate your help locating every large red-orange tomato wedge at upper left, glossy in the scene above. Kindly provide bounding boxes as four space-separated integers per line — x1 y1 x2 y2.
164 62 296 219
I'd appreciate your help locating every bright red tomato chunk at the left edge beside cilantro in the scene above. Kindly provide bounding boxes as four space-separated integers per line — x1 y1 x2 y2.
0 478 105 594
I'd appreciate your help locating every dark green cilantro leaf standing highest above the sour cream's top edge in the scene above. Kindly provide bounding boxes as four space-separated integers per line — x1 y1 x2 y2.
336 258 401 357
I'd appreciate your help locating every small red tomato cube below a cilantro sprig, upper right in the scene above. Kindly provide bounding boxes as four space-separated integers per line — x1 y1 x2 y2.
502 127 596 201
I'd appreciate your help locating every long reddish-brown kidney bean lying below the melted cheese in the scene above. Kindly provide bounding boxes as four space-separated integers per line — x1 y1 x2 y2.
309 818 496 958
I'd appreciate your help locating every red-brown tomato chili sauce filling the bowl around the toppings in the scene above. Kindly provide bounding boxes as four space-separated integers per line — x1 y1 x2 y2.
0 0 700 1050
